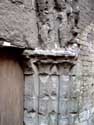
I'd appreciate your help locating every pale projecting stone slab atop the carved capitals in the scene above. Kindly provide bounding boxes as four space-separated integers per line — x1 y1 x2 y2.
23 49 78 64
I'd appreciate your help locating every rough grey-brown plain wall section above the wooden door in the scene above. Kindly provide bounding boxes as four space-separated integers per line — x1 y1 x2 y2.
0 0 38 48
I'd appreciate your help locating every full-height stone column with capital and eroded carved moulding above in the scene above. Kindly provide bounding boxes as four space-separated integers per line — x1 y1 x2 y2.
24 0 80 125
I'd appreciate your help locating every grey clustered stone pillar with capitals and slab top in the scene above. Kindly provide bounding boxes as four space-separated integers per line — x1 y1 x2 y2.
24 50 78 125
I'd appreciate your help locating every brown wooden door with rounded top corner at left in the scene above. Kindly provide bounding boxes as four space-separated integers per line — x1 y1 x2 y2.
0 56 24 125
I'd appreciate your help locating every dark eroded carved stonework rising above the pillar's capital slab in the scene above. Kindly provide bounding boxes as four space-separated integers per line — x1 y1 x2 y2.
37 0 79 49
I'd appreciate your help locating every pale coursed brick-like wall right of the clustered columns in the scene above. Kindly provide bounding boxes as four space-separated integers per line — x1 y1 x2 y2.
72 0 94 125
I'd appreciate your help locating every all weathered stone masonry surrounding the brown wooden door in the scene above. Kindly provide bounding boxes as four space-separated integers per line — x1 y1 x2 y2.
0 0 94 125
